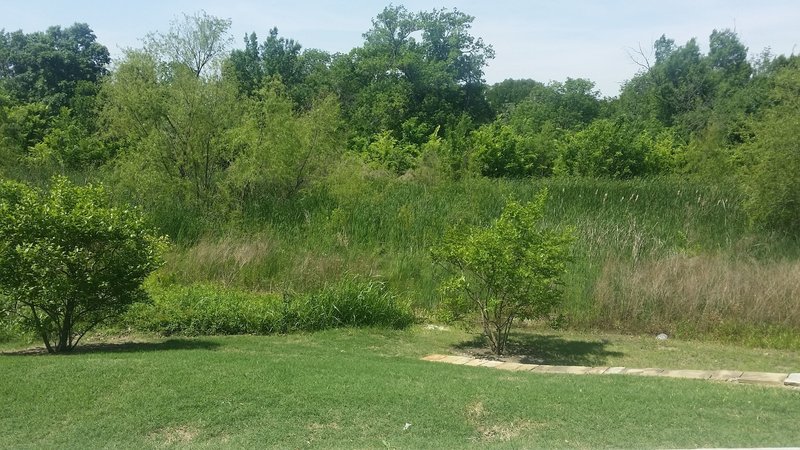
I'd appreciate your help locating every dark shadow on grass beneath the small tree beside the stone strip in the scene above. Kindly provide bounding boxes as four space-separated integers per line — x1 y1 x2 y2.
454 332 623 366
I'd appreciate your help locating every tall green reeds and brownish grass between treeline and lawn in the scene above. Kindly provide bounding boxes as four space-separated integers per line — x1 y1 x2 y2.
160 174 800 348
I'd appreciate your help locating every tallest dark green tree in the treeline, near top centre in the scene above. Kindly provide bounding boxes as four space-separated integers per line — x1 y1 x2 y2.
331 6 494 149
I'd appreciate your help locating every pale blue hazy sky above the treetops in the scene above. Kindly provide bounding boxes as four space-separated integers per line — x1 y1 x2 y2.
0 0 800 96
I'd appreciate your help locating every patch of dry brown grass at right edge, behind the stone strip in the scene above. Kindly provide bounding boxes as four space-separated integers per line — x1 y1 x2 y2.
595 254 800 332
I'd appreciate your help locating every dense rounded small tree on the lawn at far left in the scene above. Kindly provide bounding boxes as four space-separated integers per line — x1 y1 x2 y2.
0 177 165 353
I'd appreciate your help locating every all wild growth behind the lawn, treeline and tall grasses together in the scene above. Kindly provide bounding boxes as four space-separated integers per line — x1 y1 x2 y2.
0 6 800 347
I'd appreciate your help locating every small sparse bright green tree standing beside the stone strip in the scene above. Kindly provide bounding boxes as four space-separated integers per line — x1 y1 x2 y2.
432 191 572 355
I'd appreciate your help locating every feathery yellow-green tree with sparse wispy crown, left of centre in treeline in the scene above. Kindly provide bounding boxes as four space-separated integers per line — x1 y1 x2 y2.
101 14 242 210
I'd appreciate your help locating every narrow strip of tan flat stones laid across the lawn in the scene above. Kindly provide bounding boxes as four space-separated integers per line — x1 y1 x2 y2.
422 355 800 387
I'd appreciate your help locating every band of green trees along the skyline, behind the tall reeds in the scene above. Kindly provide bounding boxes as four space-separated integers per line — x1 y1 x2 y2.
0 6 800 235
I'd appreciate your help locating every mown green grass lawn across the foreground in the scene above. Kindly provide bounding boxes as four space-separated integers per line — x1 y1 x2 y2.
0 328 800 448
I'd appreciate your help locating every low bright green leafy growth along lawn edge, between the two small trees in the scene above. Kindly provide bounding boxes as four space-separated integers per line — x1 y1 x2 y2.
126 277 414 335
